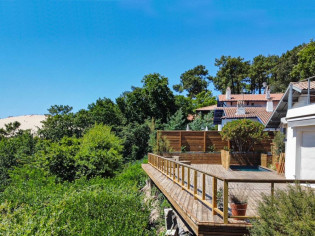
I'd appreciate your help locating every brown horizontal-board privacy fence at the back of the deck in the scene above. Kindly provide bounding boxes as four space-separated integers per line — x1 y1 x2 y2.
157 130 274 152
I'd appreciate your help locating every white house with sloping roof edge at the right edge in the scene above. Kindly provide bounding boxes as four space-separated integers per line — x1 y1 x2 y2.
267 81 315 180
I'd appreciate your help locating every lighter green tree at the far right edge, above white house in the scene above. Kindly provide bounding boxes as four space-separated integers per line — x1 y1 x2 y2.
290 41 315 79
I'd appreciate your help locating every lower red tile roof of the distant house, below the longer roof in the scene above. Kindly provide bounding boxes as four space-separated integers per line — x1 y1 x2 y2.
222 107 272 124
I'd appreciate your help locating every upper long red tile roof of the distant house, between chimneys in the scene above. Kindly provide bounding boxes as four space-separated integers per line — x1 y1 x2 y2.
218 93 283 102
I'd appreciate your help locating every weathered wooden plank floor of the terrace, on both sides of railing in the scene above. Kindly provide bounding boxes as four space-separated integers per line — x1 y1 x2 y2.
143 161 294 234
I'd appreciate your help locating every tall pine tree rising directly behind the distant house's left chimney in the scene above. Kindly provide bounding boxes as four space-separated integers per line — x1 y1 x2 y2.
209 56 250 94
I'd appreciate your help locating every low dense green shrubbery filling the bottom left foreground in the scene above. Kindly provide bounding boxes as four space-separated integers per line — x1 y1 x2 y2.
0 160 155 235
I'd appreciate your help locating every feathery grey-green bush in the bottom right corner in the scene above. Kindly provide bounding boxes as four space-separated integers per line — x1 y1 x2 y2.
250 185 315 236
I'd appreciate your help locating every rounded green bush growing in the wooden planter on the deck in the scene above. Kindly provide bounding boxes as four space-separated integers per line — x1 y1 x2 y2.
220 119 268 152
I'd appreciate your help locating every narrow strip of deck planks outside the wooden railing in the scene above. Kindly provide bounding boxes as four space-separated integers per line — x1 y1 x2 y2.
142 164 254 235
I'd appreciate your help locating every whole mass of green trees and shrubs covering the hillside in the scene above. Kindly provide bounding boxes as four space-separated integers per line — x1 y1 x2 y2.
0 41 315 235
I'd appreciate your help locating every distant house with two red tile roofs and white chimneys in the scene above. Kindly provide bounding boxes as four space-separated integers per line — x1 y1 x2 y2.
196 87 283 130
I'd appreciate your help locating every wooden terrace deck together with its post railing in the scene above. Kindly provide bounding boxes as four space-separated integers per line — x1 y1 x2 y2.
142 154 315 235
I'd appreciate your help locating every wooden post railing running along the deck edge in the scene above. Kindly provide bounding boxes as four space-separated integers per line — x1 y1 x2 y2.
148 153 315 224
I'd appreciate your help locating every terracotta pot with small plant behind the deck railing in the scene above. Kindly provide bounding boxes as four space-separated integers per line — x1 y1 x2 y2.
230 188 248 216
